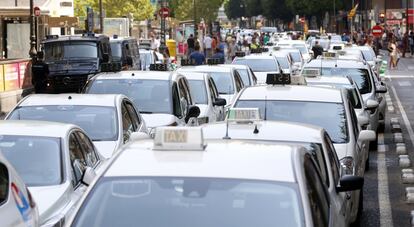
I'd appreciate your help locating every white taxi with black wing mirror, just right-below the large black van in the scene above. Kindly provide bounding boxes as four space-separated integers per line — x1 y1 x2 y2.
83 71 200 129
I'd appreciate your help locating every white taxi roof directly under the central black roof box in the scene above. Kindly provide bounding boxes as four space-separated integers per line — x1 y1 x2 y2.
239 85 343 103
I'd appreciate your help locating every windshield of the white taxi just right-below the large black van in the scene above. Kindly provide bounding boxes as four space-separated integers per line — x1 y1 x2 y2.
86 79 172 114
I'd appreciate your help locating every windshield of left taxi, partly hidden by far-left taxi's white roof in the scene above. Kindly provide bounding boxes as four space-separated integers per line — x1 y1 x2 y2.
8 105 118 141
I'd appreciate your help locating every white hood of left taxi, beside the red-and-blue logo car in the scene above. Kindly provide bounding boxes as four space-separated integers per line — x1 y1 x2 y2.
29 182 72 224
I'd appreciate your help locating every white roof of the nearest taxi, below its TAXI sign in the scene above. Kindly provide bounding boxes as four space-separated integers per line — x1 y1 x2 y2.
104 140 301 182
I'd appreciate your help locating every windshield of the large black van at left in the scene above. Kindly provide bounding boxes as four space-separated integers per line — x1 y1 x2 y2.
44 41 98 61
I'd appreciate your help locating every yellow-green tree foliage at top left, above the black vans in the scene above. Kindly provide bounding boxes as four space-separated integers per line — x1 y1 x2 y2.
74 0 154 20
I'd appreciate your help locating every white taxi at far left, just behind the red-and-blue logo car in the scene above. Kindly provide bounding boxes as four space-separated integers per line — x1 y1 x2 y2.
0 121 103 227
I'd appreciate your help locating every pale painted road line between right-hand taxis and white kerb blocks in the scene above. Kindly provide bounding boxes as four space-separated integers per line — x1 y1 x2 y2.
377 133 394 227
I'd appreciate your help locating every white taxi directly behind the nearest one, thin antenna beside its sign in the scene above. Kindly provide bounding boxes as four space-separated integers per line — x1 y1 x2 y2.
203 108 362 224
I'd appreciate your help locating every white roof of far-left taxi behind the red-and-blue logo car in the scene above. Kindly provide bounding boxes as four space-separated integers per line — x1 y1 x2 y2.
0 120 78 138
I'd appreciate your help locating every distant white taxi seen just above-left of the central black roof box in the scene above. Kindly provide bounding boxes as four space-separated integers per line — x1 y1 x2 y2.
232 55 283 84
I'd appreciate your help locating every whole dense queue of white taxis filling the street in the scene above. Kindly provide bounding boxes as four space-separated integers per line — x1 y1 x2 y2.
0 36 387 227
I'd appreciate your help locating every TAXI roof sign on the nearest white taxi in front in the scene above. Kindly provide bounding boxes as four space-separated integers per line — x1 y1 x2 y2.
153 127 206 151
